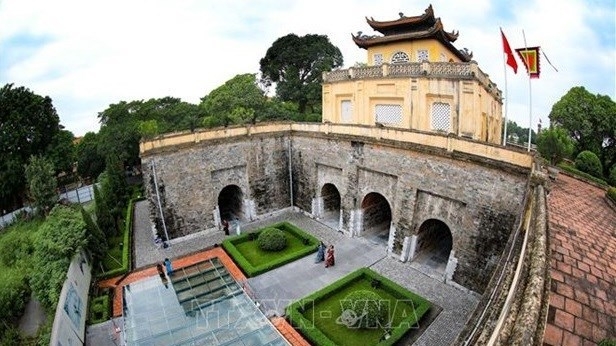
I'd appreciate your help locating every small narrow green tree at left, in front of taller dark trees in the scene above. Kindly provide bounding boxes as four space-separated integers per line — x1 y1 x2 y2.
26 156 58 214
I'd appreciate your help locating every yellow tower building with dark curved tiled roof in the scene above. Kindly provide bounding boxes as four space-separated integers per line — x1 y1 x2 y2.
323 5 503 144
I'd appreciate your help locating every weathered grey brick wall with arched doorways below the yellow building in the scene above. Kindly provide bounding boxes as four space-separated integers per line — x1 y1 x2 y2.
143 133 527 293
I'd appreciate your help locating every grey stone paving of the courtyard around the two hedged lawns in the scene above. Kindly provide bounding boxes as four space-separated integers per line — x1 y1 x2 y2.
134 201 479 345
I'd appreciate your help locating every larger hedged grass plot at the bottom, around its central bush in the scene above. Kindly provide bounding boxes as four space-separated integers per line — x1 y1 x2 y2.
286 268 430 345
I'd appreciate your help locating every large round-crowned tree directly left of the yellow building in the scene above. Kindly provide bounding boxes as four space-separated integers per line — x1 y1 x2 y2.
260 34 343 113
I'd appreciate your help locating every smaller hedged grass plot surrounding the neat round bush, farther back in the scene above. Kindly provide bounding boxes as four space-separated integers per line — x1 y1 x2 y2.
222 222 319 277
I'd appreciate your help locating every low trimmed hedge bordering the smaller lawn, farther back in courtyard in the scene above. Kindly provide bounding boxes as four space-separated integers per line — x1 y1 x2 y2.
222 222 319 277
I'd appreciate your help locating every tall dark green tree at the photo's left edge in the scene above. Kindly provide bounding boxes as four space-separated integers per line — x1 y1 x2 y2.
0 84 60 209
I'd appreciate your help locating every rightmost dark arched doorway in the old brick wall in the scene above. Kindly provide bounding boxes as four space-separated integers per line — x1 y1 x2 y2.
413 219 453 273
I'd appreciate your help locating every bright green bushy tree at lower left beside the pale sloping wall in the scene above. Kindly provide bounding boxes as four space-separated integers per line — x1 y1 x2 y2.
29 205 87 311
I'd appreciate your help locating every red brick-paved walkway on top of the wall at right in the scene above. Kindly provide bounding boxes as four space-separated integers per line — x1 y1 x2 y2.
543 174 616 345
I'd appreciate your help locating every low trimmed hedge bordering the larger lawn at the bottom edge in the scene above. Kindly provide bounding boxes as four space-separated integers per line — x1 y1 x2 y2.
286 268 430 346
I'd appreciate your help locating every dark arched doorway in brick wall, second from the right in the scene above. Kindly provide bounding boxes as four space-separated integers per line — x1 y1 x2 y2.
361 192 391 245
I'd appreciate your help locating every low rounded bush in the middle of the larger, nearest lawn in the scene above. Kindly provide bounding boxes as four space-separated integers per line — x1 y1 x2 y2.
340 290 388 329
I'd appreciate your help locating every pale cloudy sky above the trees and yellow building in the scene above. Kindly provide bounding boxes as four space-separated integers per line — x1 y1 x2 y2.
0 0 616 136
